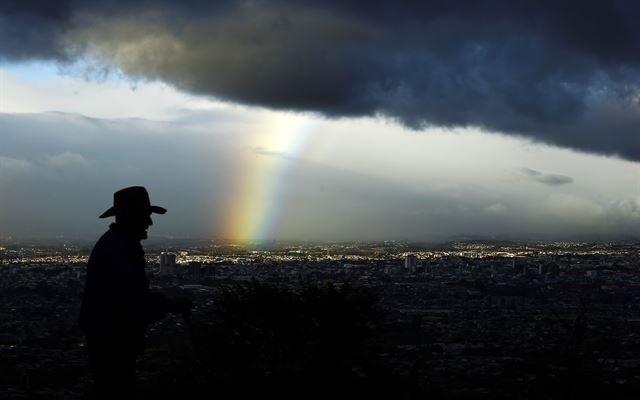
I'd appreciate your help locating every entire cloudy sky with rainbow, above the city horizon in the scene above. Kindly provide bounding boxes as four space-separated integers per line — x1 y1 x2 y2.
0 0 640 241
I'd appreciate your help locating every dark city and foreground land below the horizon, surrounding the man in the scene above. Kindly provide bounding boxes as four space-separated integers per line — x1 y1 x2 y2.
0 242 640 399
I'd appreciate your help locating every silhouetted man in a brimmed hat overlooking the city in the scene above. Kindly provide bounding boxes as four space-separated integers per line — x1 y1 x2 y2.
79 186 191 399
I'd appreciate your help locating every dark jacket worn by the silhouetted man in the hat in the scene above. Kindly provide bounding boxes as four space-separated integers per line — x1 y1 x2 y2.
79 224 170 353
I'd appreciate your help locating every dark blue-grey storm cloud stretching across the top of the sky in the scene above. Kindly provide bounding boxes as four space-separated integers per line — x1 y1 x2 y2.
0 0 640 160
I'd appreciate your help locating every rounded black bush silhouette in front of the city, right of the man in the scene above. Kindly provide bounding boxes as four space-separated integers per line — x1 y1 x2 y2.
188 283 379 398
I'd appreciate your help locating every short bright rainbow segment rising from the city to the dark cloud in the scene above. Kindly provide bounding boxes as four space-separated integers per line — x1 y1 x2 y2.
214 112 318 242
